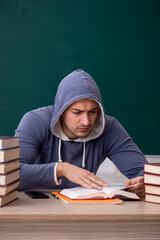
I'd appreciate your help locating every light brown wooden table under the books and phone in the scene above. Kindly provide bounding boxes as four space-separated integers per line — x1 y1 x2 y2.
0 192 160 240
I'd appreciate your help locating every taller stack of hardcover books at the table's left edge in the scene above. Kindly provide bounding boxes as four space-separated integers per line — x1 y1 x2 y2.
0 136 20 207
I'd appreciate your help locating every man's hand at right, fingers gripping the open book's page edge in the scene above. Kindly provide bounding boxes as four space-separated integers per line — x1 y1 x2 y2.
124 177 144 199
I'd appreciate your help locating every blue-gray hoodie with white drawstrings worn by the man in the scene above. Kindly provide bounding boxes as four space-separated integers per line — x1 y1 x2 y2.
15 69 146 189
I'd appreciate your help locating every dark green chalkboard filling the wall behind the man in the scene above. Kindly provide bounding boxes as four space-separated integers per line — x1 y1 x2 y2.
0 0 160 154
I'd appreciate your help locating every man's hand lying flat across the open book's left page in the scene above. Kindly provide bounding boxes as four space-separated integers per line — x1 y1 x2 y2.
57 162 108 190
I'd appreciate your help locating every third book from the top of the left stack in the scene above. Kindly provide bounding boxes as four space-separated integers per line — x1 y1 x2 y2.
0 159 20 174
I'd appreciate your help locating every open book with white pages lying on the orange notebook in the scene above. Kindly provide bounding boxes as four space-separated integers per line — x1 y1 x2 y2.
57 185 140 199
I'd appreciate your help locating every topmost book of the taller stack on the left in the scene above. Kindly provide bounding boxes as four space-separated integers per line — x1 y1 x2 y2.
0 136 19 149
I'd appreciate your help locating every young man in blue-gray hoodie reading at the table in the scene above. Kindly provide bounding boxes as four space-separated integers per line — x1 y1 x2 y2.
15 70 147 197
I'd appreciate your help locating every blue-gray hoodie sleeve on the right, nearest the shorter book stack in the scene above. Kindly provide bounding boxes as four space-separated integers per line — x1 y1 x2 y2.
105 118 147 178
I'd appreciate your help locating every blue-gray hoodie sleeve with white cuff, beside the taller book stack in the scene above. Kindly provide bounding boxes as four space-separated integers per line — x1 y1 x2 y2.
15 112 59 190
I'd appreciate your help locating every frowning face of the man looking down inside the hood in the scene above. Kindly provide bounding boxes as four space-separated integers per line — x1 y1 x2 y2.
61 98 99 139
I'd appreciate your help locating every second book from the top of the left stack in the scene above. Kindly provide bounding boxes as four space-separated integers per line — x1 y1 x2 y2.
0 147 20 162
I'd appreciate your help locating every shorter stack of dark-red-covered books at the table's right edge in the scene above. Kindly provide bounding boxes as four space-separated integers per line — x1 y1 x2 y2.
144 163 160 203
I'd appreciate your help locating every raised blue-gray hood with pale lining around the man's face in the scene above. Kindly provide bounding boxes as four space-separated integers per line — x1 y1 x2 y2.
50 69 105 142
